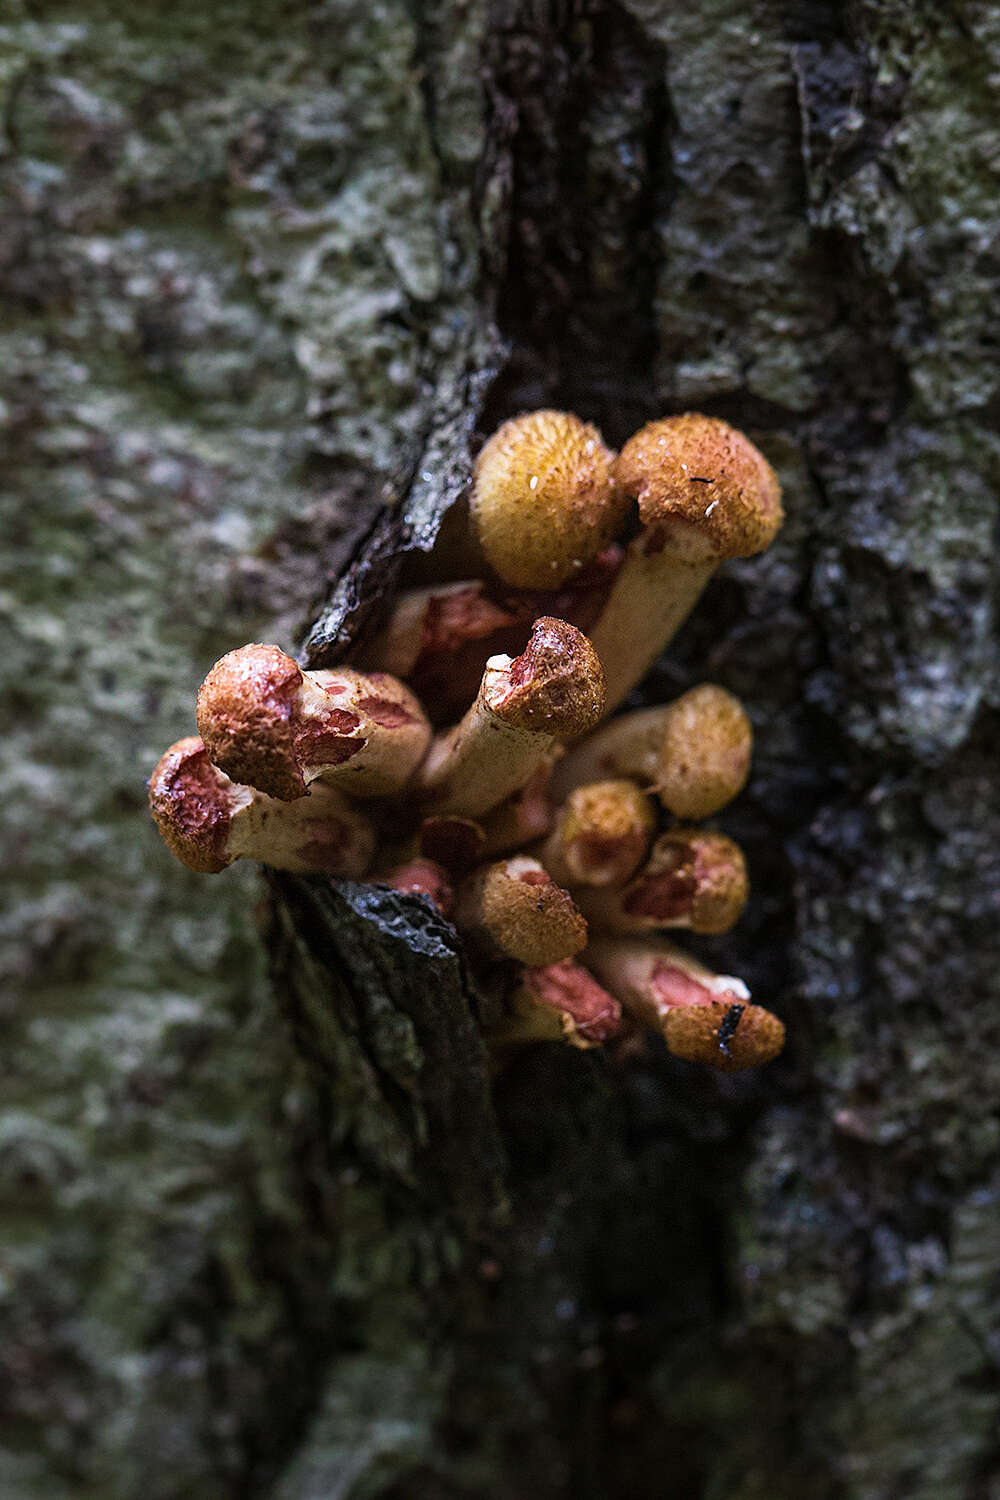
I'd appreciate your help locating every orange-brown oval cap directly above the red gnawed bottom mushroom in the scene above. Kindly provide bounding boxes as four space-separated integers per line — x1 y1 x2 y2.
481 857 586 968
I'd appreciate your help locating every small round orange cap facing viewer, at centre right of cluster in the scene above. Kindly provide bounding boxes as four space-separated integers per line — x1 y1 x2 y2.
540 780 657 885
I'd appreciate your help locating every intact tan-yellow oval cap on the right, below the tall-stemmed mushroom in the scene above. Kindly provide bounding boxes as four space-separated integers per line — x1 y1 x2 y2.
655 683 753 821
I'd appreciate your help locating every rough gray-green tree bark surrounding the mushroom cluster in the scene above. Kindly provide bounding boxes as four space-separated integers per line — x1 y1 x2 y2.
0 0 1000 1500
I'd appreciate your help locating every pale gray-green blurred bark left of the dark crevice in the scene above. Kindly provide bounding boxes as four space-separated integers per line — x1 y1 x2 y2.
0 3 491 1500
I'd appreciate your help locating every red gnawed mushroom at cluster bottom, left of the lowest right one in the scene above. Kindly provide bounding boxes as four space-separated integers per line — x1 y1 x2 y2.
487 959 622 1049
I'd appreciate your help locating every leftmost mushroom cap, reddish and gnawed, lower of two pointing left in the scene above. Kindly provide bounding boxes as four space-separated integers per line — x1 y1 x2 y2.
150 735 250 875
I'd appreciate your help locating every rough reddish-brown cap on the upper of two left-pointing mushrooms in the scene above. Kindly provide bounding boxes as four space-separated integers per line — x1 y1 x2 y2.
198 645 307 803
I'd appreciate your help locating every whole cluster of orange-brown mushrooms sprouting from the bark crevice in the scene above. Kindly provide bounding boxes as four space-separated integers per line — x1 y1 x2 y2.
150 411 784 1071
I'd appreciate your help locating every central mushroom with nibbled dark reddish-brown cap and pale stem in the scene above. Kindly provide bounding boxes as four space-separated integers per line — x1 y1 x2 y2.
420 617 604 818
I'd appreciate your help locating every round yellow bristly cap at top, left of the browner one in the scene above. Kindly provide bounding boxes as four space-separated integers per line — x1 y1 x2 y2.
471 411 628 588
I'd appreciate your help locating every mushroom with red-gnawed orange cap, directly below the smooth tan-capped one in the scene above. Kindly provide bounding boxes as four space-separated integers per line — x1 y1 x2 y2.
577 828 748 933
